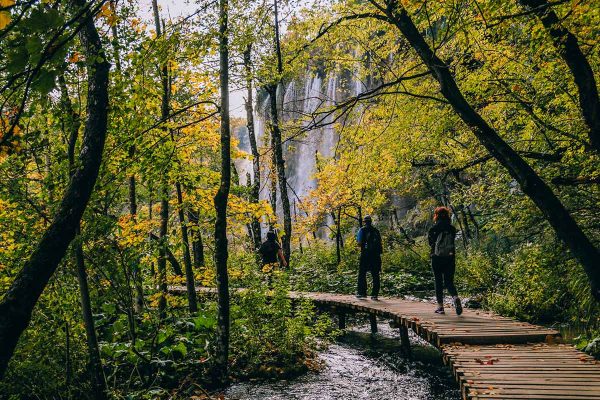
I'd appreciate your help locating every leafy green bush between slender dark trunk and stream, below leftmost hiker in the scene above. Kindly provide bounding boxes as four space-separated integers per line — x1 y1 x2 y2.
231 271 332 379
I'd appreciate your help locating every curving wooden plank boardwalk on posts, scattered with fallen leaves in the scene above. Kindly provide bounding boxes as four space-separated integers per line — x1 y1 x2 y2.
171 287 600 400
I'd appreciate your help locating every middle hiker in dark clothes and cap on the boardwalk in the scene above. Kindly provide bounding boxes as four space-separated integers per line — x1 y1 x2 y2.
356 215 383 300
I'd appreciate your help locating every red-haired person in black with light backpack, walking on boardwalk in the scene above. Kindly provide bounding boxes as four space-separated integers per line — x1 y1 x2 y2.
427 207 462 315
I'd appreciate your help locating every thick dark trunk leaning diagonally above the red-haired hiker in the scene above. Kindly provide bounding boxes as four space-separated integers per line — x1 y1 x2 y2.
380 0 600 300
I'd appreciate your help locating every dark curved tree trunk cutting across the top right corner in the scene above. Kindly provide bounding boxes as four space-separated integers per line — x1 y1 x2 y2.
519 0 600 153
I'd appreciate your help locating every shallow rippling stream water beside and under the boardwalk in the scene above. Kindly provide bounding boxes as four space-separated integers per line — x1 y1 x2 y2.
225 321 460 400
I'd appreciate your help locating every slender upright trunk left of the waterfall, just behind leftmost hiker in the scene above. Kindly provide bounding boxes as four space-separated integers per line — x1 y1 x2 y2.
244 44 262 250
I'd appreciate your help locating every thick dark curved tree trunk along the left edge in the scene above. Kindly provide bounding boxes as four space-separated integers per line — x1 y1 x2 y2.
0 0 110 379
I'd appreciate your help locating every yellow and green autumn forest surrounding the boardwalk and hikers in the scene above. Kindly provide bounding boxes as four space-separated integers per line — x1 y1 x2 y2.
0 0 600 400
